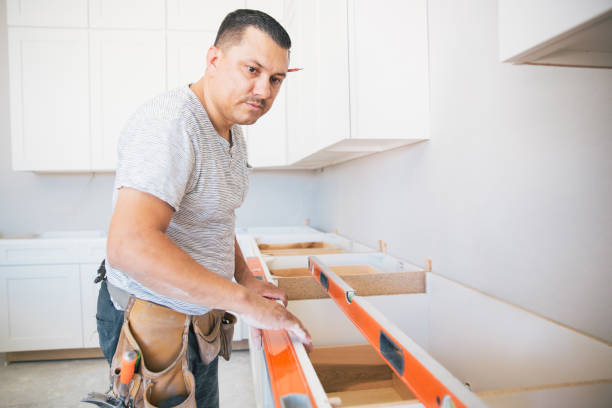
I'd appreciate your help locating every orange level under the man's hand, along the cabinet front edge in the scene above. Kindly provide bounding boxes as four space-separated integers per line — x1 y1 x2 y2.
246 257 316 408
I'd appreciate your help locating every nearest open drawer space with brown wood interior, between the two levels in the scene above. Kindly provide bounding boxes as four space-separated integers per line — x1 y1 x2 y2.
309 344 416 407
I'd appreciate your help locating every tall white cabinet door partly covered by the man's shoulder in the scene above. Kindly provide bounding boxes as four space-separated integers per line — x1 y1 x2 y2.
90 30 166 170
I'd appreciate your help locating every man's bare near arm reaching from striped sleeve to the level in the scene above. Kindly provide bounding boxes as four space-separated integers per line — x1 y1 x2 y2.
106 187 311 347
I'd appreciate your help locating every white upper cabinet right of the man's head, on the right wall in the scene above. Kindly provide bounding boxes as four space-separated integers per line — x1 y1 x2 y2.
287 0 429 168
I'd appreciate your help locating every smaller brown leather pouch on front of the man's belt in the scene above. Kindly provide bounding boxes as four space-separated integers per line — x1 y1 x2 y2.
191 309 236 364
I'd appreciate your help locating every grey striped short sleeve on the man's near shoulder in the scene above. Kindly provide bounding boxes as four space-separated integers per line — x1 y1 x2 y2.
115 117 195 211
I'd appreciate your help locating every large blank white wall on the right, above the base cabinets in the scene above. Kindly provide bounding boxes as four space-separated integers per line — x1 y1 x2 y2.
313 0 612 341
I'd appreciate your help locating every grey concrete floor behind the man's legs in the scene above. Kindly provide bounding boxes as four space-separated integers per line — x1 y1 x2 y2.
0 351 255 408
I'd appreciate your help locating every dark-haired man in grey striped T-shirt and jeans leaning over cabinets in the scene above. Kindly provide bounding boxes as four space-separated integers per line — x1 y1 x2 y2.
97 10 311 407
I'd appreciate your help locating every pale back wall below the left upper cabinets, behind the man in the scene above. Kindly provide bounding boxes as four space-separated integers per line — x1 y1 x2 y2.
0 0 314 237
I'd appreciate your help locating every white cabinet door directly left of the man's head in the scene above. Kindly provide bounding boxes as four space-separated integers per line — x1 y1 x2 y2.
167 31 216 89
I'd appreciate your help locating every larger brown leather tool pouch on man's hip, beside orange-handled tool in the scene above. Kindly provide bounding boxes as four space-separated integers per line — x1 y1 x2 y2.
111 297 196 408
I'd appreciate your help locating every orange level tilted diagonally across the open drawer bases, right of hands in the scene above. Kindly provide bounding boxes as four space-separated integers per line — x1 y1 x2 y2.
308 256 484 408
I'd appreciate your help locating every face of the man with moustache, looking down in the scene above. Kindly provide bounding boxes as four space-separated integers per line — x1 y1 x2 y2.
209 27 289 125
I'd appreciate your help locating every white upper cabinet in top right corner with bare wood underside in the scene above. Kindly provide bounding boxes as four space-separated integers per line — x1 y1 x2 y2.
498 0 612 68
